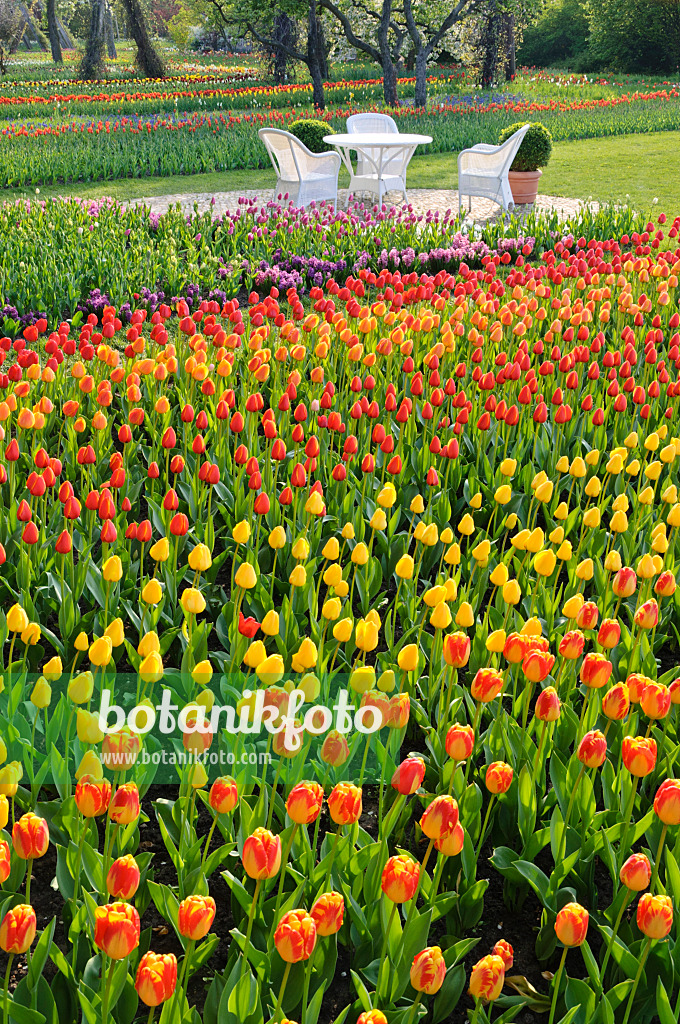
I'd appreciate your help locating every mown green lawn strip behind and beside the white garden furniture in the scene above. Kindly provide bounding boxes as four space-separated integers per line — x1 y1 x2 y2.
4 132 680 215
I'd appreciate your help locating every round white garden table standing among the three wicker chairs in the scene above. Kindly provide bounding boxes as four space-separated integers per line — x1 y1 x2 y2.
324 132 432 203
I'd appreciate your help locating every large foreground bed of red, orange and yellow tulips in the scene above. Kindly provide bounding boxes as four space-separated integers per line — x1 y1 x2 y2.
0 205 680 1024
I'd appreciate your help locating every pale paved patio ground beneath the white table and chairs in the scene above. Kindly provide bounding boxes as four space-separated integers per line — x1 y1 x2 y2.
124 188 585 223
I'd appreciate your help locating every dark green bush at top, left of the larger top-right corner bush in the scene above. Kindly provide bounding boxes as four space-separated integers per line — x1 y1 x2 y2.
517 0 589 71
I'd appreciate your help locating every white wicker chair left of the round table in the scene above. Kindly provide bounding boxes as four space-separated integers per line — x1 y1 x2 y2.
257 128 342 206
